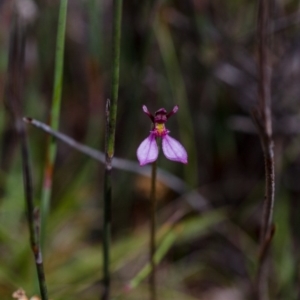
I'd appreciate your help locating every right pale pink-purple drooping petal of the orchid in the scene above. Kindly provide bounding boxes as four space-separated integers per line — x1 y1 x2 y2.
162 134 188 164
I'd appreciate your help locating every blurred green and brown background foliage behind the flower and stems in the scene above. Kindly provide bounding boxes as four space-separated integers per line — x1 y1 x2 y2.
0 0 300 300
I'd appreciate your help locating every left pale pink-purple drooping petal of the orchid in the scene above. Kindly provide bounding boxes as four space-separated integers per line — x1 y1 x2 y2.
136 133 158 166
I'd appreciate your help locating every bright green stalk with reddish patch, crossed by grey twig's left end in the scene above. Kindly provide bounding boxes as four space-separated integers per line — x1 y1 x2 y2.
41 0 68 246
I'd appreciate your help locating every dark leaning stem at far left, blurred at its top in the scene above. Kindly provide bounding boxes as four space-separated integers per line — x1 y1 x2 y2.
5 15 48 300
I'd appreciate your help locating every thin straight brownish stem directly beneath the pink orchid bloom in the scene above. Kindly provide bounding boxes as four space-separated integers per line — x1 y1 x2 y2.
149 162 157 300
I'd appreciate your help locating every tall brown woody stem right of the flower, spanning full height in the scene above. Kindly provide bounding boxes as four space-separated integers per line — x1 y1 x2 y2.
254 0 275 300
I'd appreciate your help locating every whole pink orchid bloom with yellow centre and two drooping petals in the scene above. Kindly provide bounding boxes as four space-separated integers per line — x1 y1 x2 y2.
136 105 188 166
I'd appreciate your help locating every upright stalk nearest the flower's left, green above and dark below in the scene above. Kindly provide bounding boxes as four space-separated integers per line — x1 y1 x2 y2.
102 0 123 300
